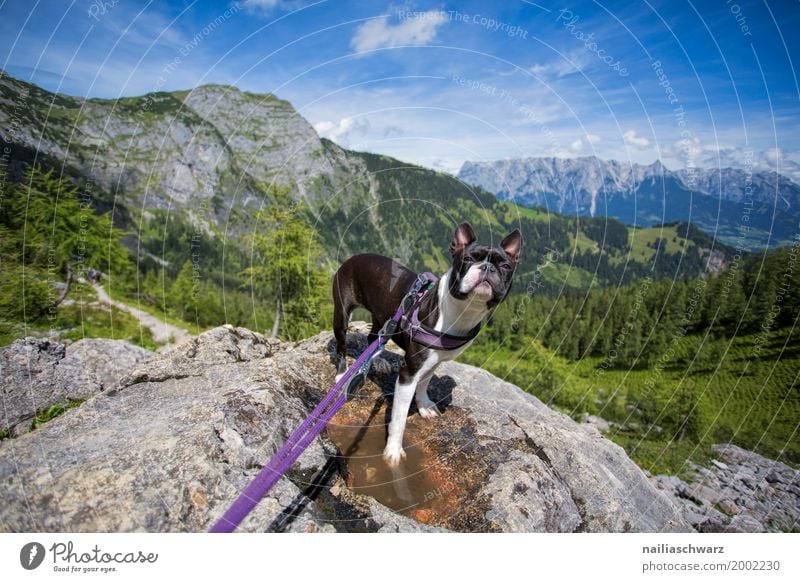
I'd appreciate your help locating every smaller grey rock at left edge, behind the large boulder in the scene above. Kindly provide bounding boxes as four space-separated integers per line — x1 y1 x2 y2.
0 337 153 438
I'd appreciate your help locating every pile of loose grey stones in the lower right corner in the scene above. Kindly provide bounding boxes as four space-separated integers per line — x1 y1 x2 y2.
653 444 800 532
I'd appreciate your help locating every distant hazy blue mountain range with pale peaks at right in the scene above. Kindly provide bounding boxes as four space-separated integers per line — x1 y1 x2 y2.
458 156 800 250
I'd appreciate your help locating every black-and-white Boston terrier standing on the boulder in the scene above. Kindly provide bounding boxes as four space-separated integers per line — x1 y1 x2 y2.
333 222 522 467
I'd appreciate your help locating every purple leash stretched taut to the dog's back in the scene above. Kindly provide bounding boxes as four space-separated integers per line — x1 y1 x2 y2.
203 273 436 533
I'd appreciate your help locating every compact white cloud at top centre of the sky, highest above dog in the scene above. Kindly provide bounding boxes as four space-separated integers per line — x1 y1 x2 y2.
350 10 448 52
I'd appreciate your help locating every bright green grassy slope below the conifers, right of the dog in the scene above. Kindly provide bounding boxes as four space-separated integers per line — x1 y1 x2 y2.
461 329 800 475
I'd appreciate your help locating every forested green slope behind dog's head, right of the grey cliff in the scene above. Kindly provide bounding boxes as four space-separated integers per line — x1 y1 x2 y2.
315 151 733 292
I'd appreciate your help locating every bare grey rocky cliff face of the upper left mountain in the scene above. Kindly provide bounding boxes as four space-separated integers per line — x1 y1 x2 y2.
0 73 325 230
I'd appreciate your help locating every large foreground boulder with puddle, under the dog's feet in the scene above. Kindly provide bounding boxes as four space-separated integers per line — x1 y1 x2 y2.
0 326 691 532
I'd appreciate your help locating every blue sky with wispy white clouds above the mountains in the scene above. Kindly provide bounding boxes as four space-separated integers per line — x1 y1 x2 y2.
0 0 800 181
